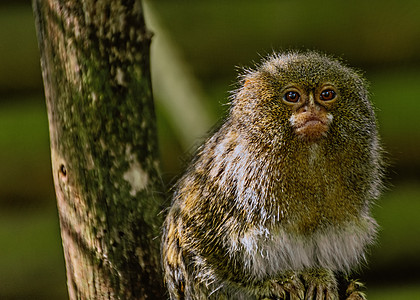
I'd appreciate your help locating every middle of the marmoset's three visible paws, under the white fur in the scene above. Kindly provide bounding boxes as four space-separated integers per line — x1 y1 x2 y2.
302 269 338 300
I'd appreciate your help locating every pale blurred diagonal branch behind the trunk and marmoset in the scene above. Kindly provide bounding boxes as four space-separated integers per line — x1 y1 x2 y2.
144 1 214 149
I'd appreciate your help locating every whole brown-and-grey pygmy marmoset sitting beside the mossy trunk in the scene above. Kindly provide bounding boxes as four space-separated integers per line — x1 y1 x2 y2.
162 51 382 300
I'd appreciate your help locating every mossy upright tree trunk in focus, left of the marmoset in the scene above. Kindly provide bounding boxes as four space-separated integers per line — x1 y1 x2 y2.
33 0 164 299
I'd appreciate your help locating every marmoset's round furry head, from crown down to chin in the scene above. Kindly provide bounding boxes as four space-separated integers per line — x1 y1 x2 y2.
231 52 376 145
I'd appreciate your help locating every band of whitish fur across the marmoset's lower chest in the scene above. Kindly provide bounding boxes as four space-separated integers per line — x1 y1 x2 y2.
230 217 377 279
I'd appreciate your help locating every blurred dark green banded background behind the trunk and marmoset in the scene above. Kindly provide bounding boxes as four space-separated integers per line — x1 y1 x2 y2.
0 0 420 300
